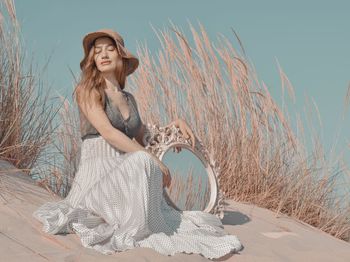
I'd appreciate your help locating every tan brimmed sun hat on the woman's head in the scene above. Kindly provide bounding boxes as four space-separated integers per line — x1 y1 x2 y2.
80 29 139 75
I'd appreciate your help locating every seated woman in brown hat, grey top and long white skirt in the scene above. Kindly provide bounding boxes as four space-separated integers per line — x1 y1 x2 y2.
33 29 242 259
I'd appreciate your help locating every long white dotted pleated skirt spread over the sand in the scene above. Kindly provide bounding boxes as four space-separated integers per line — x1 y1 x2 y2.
33 136 242 259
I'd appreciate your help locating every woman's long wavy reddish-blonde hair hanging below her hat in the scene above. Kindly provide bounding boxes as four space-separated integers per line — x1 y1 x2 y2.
72 38 127 109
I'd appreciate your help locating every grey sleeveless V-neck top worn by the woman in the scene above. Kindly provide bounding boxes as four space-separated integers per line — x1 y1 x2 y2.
78 90 142 140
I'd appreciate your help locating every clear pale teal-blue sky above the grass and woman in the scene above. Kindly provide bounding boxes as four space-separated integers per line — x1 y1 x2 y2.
15 0 350 172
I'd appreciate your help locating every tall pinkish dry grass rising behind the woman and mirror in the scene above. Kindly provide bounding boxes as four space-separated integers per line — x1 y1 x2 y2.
1 1 350 244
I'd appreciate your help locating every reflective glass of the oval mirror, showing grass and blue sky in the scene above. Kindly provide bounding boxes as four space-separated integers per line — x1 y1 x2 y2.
161 146 210 211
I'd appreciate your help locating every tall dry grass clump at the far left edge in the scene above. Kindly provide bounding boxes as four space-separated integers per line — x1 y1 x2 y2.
0 1 60 190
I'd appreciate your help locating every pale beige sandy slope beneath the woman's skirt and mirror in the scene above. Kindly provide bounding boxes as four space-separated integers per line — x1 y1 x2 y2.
0 162 350 262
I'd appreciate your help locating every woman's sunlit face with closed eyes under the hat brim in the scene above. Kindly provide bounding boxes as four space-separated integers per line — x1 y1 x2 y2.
93 37 123 73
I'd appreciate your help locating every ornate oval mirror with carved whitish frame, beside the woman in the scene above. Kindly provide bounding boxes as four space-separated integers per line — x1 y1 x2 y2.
144 123 224 219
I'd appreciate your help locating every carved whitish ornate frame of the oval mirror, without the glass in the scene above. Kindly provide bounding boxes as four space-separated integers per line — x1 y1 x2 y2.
143 123 225 219
